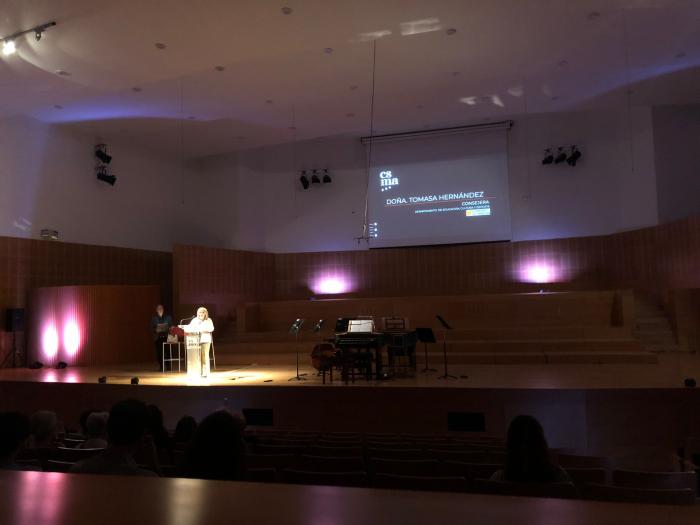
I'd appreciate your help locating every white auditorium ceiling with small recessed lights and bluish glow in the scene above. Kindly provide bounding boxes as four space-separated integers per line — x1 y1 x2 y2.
0 0 700 157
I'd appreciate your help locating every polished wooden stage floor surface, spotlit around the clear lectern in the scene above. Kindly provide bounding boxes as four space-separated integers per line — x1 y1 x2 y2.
0 354 700 389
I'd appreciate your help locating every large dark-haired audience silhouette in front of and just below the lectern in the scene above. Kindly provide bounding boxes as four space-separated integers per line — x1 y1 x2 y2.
181 410 245 480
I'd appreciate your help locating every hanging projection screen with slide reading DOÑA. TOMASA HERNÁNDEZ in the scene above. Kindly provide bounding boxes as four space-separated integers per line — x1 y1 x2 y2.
369 132 511 247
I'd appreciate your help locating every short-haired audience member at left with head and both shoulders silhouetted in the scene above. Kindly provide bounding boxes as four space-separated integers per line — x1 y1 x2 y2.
70 399 156 476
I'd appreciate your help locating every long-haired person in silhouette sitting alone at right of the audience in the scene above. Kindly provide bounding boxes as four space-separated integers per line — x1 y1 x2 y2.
491 416 571 483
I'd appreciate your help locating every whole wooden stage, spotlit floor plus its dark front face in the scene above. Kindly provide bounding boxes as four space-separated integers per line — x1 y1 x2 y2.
0 354 700 457
